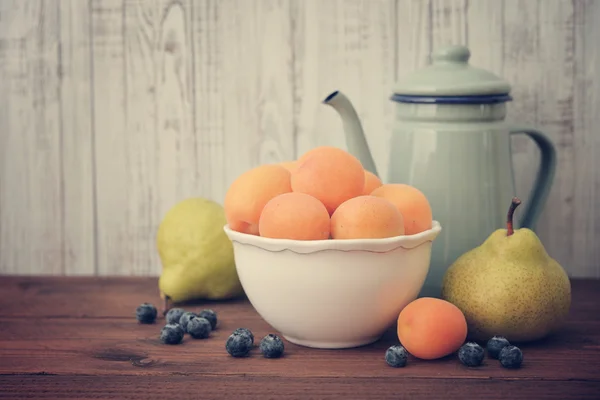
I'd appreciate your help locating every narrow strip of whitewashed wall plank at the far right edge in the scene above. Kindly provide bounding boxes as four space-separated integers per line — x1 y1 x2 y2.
572 0 600 276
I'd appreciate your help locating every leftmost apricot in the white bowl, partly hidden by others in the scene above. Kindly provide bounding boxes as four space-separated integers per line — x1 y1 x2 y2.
223 164 292 235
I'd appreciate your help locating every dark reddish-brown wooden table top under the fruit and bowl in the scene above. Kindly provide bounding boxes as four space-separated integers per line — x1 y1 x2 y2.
0 276 600 400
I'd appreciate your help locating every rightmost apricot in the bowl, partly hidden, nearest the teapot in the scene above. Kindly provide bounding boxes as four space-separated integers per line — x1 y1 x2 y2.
371 183 433 235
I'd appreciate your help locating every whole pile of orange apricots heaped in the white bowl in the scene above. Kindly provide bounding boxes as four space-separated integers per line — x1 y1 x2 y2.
224 146 432 240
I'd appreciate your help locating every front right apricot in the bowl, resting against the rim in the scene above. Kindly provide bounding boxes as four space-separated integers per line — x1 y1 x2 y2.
331 195 404 239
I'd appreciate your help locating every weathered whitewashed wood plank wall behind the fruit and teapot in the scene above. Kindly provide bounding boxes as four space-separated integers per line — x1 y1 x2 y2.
0 0 600 276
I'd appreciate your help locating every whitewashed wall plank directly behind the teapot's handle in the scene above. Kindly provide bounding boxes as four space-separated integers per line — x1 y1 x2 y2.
503 0 585 275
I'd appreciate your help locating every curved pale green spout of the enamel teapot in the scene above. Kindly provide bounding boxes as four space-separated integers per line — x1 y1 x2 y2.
323 90 379 176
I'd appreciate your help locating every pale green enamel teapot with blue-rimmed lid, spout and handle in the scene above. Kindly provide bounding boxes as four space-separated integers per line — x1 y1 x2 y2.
323 46 556 297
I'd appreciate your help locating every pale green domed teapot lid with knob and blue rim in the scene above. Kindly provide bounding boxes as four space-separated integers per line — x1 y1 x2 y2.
392 46 512 104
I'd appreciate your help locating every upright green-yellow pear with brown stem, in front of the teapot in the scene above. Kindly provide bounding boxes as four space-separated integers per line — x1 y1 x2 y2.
442 198 571 342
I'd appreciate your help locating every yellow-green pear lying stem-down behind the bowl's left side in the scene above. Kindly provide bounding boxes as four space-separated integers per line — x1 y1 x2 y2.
156 198 243 312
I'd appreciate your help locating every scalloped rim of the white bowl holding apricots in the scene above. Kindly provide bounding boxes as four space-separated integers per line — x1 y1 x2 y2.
223 220 442 254
